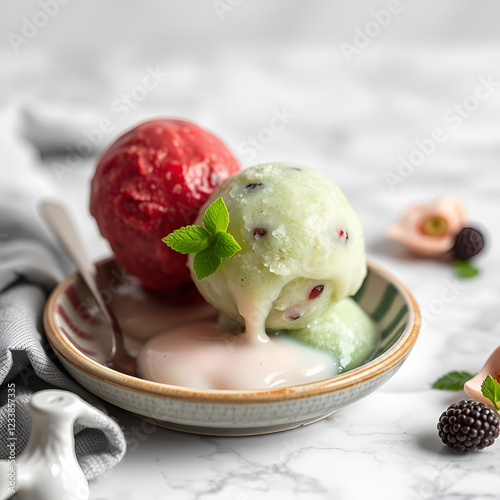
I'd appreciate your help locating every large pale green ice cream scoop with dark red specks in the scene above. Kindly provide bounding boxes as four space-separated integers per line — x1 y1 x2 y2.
189 163 366 329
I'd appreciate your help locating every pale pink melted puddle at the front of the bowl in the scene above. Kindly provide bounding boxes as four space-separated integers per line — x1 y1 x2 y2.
137 321 338 390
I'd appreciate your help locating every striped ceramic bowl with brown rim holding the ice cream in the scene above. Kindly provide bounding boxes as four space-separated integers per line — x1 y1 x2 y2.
44 260 420 436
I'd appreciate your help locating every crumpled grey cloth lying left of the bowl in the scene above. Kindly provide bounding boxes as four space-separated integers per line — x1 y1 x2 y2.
0 195 126 479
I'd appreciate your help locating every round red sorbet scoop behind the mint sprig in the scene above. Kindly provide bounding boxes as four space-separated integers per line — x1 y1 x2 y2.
90 119 240 290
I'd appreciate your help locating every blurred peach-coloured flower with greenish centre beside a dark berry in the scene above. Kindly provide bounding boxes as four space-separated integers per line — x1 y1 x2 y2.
387 196 467 257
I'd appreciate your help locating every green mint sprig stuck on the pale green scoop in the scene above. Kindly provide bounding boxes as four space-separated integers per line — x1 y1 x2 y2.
162 198 241 280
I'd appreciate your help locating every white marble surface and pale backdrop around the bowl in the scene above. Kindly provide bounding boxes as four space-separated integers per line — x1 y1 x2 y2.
0 0 500 500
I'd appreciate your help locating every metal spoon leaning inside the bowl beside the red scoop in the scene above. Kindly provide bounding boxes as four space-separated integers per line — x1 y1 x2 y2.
40 201 137 376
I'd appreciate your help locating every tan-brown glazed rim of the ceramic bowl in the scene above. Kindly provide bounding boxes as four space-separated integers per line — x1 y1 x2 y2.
43 258 421 404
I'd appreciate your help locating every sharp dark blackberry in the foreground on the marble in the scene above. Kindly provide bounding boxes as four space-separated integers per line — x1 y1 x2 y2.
437 399 499 451
